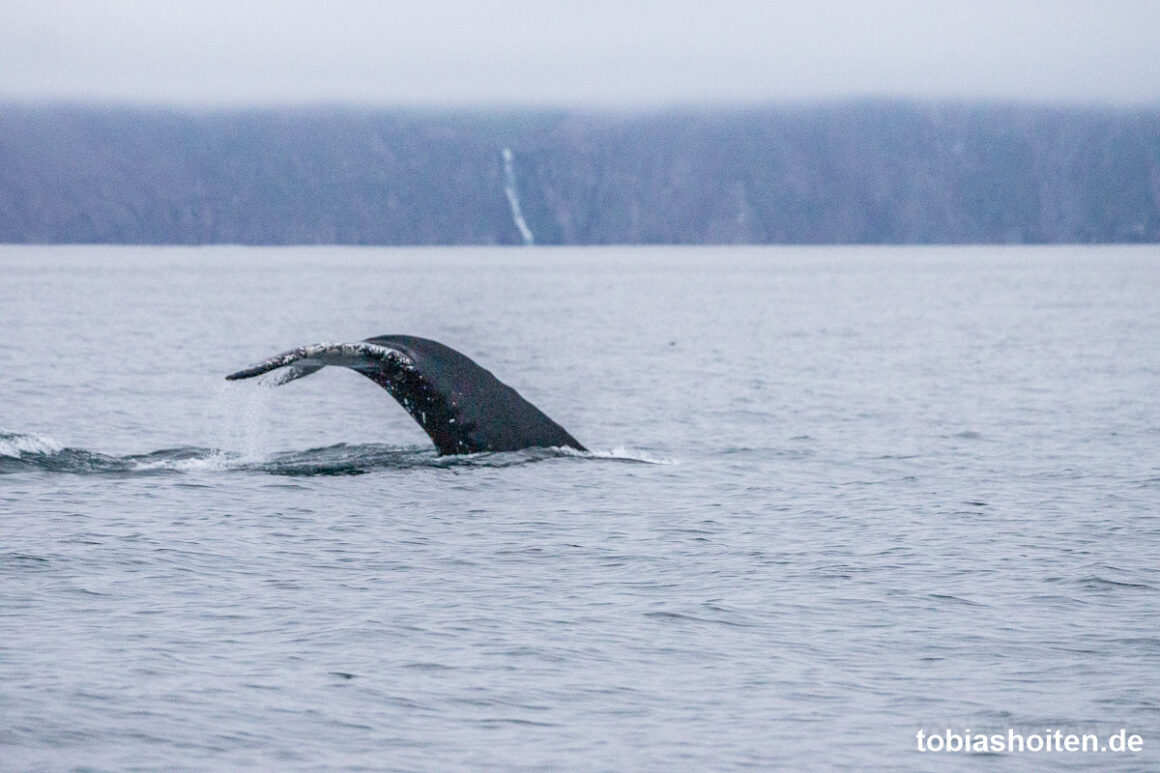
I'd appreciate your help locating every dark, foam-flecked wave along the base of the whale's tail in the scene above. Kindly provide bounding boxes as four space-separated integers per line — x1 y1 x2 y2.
0 429 673 476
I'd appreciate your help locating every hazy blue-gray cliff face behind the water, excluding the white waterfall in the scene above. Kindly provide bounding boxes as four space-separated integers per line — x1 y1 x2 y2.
0 102 1160 245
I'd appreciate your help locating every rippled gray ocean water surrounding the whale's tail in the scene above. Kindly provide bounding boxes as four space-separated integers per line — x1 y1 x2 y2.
0 246 1160 771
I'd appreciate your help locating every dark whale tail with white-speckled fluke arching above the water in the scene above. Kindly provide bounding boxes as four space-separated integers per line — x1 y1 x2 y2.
226 335 587 455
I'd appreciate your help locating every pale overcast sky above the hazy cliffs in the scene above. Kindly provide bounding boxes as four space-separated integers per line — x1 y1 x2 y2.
0 0 1160 107
